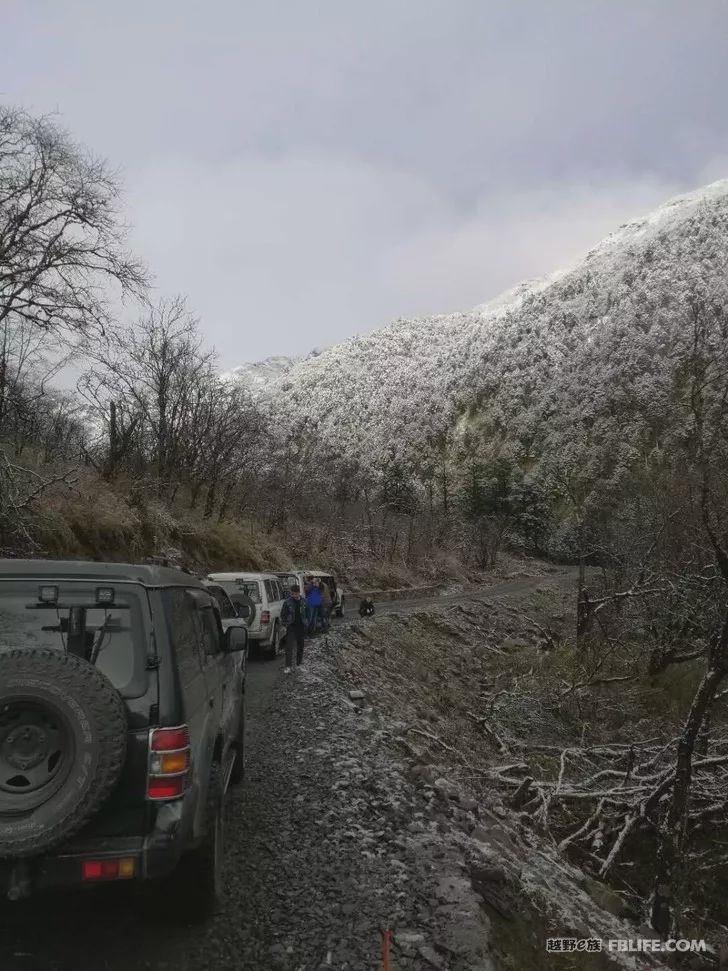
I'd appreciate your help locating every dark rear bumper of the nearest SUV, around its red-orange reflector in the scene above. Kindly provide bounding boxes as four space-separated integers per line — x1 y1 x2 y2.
0 833 190 900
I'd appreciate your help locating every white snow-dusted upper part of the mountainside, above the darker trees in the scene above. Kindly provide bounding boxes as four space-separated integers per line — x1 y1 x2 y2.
239 180 728 474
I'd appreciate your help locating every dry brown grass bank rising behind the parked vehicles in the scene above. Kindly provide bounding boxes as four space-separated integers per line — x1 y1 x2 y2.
19 466 506 589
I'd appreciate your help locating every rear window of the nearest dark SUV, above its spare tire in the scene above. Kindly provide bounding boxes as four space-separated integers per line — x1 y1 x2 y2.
0 579 149 698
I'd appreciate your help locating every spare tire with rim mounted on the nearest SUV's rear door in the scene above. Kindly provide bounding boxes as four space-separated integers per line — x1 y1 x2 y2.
0 649 127 859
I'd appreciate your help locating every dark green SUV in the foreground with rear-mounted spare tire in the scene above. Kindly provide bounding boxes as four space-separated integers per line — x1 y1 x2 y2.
0 560 247 920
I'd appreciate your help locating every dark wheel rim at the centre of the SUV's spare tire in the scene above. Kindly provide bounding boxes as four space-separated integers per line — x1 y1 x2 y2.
0 700 74 815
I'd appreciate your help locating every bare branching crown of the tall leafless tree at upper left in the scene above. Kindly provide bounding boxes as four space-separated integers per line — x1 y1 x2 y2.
0 107 146 331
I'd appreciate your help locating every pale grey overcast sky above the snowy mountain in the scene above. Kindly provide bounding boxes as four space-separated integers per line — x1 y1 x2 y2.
0 0 728 367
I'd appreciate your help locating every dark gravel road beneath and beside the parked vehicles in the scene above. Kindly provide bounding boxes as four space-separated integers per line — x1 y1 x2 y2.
0 578 568 971
